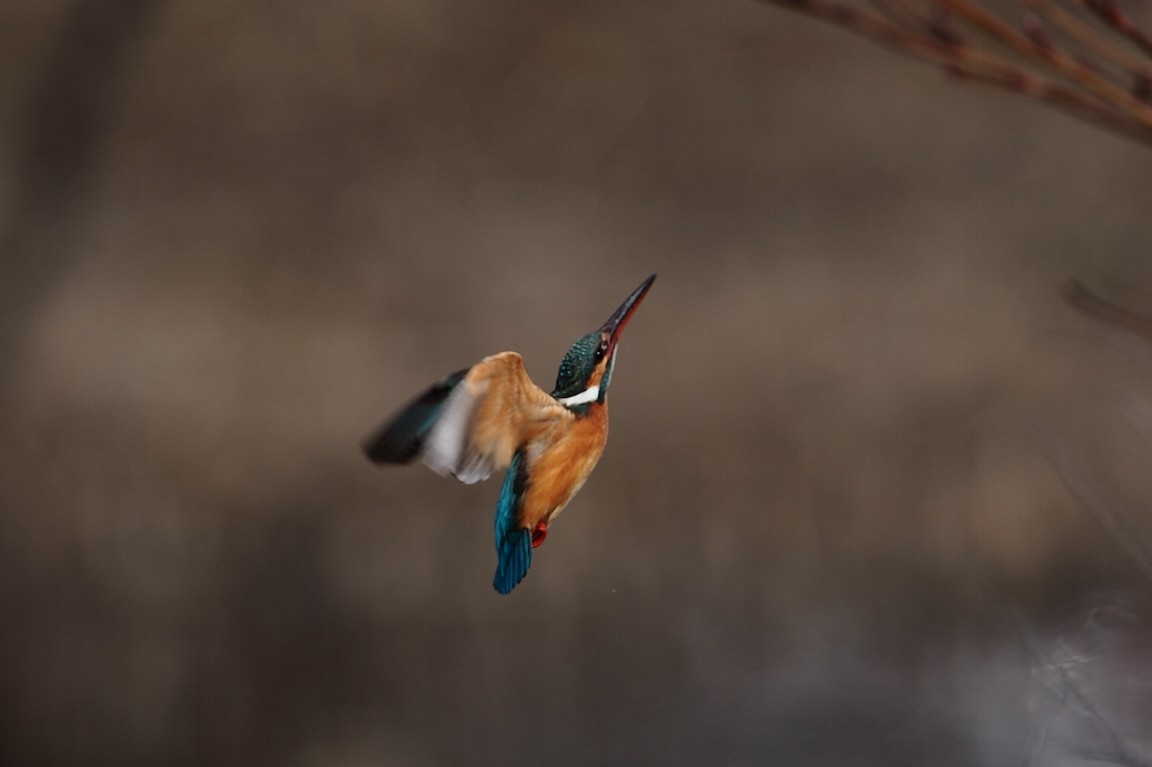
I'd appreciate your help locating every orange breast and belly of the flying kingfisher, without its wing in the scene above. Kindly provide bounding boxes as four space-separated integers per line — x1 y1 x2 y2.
520 403 608 529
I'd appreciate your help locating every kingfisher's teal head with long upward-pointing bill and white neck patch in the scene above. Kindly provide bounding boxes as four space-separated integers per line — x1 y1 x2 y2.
552 274 655 412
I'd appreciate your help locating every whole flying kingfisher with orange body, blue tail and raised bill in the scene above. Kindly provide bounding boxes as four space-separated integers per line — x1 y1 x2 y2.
363 274 655 594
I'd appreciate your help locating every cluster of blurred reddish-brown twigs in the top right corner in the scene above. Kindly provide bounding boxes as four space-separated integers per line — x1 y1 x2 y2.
764 0 1152 146
